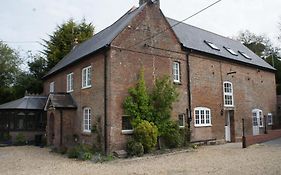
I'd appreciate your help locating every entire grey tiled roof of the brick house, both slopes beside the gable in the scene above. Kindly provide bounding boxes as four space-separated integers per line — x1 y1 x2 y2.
45 3 275 77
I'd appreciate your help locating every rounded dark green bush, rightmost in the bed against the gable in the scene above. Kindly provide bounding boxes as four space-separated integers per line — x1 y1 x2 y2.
161 121 184 148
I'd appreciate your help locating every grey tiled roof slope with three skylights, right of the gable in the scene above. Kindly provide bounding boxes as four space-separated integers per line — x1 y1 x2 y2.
167 18 275 70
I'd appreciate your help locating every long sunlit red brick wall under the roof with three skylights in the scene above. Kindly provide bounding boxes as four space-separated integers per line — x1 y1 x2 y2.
189 54 276 141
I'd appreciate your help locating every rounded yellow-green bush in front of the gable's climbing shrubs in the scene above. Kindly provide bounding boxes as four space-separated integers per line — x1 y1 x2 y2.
134 120 158 153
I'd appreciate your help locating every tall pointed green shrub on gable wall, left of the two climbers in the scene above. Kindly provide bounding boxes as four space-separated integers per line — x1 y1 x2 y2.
123 68 152 122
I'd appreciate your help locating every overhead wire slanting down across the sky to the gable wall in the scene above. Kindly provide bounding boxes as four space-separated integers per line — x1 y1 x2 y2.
128 0 222 49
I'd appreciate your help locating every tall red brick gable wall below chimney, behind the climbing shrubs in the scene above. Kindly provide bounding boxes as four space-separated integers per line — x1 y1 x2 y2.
109 6 188 150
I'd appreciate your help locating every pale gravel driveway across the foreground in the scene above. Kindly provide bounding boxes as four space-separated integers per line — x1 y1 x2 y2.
0 139 281 175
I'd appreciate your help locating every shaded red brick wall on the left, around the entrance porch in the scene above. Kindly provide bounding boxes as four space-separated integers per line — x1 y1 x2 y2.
44 53 104 149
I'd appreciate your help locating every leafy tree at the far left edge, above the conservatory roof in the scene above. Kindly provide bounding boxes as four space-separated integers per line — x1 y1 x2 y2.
0 41 22 104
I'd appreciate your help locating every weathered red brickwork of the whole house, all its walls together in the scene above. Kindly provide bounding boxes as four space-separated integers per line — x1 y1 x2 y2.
44 1 276 152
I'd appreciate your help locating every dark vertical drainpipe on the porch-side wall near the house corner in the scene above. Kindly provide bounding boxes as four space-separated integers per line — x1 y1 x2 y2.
104 46 109 155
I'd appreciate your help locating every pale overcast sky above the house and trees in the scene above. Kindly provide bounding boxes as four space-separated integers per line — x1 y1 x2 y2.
0 0 281 61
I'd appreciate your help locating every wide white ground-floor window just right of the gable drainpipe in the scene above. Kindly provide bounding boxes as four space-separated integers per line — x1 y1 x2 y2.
194 107 212 127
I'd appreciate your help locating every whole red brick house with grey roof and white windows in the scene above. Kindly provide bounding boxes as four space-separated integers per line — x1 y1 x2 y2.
44 0 276 152
